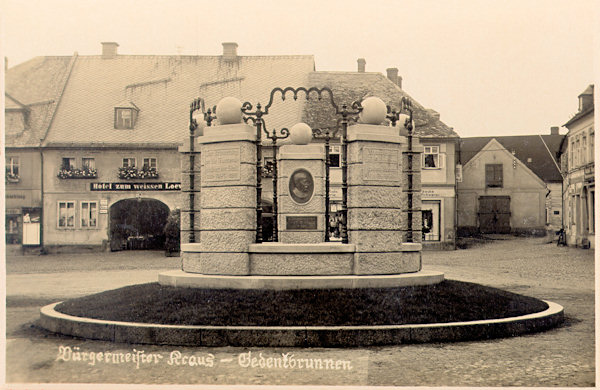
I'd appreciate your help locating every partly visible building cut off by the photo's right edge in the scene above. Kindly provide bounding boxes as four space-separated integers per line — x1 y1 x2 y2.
561 85 596 248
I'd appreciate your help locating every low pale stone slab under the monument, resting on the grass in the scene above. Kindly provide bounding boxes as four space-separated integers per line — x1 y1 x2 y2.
158 270 444 290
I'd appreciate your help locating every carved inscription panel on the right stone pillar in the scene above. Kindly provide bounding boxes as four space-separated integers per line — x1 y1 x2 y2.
362 146 400 181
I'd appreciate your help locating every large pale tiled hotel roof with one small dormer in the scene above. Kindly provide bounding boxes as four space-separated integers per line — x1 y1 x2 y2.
46 55 314 146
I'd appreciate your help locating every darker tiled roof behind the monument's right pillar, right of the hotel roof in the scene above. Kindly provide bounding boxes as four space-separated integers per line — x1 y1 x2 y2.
304 72 458 138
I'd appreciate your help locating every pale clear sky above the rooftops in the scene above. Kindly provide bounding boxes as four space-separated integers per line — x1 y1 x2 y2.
0 0 600 137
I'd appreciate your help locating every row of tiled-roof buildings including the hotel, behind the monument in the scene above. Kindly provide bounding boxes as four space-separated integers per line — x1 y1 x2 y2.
6 42 458 251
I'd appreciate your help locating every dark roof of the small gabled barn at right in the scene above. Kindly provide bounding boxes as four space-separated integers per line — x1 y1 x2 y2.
459 134 565 182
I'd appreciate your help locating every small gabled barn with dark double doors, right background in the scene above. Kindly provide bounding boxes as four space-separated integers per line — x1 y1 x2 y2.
458 127 564 236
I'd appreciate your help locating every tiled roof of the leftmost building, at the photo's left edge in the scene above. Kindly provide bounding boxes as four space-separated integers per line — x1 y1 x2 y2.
5 57 73 147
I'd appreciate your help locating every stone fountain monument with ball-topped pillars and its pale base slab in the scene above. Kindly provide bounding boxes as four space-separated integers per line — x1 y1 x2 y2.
159 92 444 289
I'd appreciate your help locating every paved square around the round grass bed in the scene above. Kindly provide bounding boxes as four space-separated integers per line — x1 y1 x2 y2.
6 238 595 387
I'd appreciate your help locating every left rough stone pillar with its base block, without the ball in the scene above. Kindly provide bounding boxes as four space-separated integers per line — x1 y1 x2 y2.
181 124 256 275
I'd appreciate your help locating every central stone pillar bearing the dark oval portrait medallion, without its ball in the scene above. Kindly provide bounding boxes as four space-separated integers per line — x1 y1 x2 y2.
277 144 325 244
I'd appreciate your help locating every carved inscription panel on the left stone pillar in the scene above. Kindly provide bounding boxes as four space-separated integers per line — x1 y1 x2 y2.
202 146 241 182
